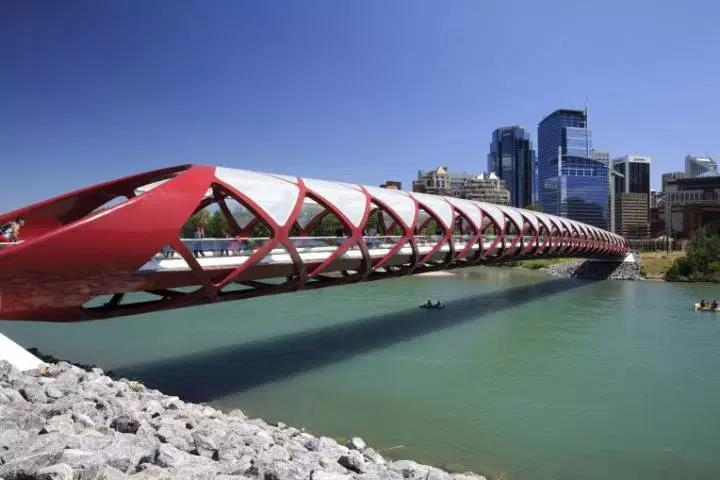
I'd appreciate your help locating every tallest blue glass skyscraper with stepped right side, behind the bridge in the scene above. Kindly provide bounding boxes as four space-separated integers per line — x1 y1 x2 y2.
538 109 609 228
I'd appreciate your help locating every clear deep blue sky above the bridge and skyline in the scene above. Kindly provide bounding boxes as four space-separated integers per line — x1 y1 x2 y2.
0 0 720 211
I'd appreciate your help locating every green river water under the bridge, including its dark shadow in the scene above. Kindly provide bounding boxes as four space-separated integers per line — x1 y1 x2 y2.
0 267 720 480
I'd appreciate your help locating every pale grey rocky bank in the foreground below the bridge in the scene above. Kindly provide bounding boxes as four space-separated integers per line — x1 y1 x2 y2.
0 361 485 480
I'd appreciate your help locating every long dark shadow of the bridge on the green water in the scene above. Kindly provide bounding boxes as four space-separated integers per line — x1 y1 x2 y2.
113 280 589 402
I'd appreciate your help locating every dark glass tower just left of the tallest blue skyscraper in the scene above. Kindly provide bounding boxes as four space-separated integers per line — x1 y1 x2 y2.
487 126 535 208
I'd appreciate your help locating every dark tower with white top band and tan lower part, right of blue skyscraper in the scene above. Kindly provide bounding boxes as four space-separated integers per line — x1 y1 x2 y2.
611 155 651 240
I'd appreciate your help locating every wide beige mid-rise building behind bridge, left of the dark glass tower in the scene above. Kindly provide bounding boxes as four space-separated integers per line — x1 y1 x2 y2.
413 166 510 205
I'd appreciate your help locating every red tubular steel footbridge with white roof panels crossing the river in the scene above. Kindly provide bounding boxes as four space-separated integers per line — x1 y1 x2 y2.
0 165 628 322
